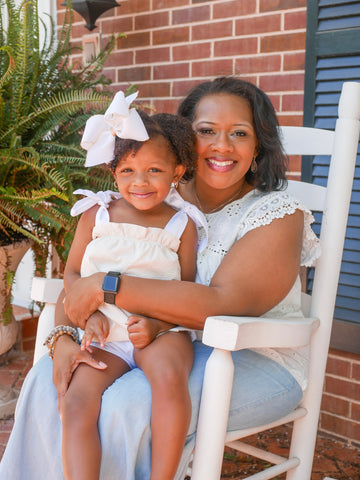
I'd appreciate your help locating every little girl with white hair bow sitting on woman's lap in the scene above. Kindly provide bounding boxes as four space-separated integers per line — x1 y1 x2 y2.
47 92 205 480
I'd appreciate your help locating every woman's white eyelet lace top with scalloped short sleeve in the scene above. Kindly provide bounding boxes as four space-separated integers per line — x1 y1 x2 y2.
196 190 320 389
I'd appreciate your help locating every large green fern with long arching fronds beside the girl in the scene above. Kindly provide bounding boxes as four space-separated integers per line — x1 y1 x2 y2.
0 0 115 354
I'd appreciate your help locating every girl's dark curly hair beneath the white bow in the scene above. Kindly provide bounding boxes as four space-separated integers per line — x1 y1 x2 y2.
110 110 197 181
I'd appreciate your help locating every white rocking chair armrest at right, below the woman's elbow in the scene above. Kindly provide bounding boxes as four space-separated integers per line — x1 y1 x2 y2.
202 316 320 351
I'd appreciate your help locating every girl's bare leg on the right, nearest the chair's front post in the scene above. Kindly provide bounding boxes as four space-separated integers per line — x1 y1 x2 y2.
135 332 193 480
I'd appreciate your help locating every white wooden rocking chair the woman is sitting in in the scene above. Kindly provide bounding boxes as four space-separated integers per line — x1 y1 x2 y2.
31 82 360 480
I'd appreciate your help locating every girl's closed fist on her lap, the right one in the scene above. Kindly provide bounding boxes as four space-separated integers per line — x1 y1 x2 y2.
127 315 174 348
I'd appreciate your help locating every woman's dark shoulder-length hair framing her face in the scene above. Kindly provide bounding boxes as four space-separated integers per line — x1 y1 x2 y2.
177 77 287 191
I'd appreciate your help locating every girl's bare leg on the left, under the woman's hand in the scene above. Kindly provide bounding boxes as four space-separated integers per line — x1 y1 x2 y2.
60 348 130 480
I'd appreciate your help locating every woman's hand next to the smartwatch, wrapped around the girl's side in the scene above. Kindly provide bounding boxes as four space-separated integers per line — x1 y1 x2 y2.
64 273 105 330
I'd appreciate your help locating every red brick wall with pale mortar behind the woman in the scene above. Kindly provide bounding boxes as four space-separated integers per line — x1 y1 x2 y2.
57 0 360 443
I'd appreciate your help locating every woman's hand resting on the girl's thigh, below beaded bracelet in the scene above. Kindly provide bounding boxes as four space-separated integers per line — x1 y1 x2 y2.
53 335 107 412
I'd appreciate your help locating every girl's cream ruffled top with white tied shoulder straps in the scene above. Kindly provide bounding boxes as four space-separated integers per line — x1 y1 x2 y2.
71 189 207 343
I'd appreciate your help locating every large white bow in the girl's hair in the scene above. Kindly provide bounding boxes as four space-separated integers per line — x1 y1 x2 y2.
80 91 149 167
